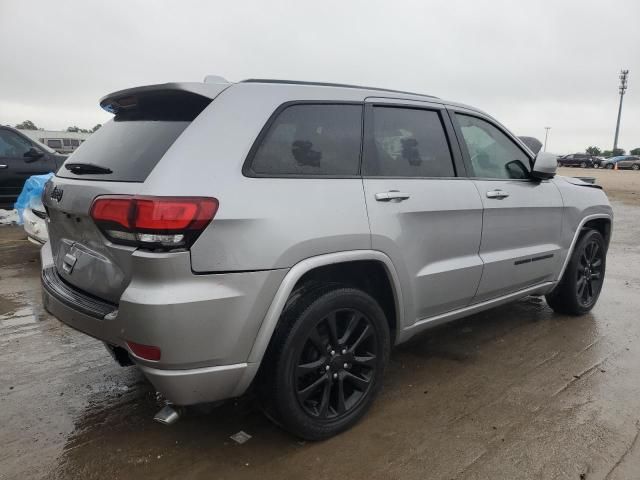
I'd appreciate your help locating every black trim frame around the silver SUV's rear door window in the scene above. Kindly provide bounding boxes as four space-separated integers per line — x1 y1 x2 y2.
360 103 466 180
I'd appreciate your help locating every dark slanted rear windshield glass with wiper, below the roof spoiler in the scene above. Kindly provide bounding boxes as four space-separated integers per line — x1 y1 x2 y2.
57 120 190 182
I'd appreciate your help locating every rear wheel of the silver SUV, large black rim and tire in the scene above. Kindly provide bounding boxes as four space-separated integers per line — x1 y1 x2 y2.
259 284 391 440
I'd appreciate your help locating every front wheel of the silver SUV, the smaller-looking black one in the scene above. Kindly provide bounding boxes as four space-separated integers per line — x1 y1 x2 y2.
546 230 607 315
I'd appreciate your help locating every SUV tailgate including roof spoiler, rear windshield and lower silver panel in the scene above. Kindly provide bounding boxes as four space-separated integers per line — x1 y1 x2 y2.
43 80 229 304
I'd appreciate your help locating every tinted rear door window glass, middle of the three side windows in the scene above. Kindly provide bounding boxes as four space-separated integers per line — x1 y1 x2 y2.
363 107 455 177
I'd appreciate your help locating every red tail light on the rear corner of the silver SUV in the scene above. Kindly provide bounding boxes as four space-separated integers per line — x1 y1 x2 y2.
90 195 218 250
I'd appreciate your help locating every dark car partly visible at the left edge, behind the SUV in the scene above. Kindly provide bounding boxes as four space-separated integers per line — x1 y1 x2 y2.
0 126 67 208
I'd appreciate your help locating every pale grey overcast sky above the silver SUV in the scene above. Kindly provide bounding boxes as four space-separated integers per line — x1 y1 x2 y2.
0 0 640 153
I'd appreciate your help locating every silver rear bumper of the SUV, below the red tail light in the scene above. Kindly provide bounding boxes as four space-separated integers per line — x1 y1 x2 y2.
41 243 286 405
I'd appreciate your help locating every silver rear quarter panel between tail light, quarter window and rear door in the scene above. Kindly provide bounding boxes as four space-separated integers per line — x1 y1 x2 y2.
140 83 371 272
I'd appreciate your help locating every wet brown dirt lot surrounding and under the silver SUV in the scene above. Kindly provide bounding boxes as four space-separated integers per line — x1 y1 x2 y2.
0 169 640 480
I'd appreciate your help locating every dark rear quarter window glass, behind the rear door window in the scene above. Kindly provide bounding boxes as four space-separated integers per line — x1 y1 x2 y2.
249 104 362 176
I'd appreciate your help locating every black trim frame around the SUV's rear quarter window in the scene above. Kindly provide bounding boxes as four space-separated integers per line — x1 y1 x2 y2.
242 100 365 179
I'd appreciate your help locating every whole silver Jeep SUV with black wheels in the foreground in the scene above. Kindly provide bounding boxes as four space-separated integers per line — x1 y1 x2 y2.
42 78 612 439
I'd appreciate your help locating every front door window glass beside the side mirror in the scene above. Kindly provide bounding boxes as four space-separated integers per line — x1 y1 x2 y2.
456 114 529 179
